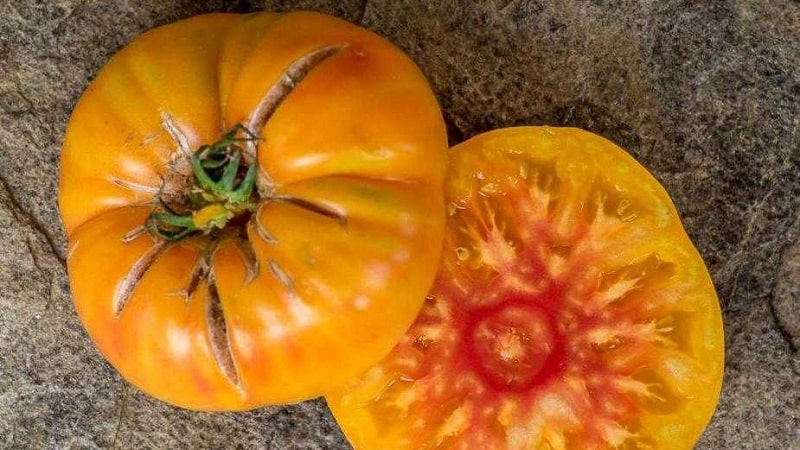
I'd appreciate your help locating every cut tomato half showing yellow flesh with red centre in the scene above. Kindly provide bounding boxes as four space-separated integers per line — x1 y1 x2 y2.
328 127 724 450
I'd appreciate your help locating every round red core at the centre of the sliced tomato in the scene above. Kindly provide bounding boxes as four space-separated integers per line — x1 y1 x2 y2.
466 299 563 389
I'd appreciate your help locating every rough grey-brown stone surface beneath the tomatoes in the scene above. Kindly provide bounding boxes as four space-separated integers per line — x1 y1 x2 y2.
0 0 800 450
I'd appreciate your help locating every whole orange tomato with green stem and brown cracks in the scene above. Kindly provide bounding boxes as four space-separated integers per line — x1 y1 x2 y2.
59 12 447 410
